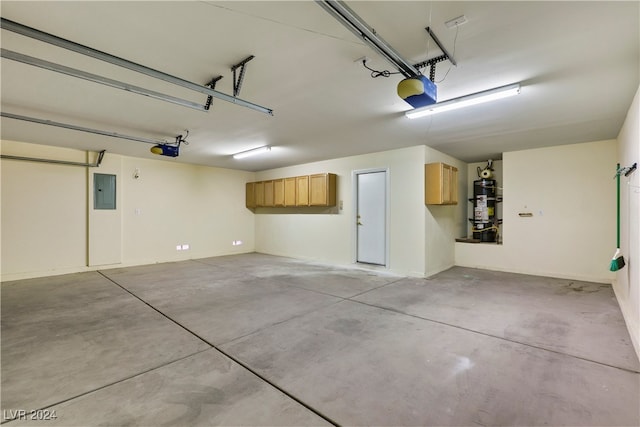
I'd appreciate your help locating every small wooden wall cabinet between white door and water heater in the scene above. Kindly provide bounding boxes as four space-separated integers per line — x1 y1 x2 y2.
424 163 458 205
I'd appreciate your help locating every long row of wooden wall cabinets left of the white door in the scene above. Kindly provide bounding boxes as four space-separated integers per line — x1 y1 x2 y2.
246 173 336 209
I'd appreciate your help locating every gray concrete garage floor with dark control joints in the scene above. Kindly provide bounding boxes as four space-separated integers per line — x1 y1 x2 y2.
1 254 640 426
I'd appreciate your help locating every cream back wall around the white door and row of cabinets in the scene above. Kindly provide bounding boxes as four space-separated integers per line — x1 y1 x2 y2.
255 146 425 276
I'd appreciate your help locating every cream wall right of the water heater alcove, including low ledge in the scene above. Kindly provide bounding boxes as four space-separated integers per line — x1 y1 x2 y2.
456 140 617 283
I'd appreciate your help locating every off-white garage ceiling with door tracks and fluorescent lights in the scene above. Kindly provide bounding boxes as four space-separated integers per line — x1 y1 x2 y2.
0 1 640 170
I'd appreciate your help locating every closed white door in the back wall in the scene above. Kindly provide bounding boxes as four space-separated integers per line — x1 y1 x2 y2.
356 171 387 265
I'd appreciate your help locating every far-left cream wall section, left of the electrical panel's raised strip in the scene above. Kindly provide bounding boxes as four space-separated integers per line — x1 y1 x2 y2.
0 141 87 280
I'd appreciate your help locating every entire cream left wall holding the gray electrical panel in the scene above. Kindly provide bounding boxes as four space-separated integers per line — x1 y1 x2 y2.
0 142 255 281
